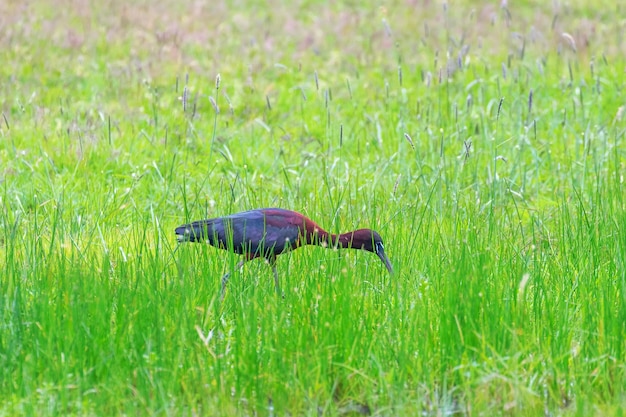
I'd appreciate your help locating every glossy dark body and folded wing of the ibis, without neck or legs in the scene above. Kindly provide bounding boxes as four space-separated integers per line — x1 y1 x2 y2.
176 208 305 258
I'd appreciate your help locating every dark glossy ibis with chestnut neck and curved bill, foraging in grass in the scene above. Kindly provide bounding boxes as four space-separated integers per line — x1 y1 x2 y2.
175 208 393 298
